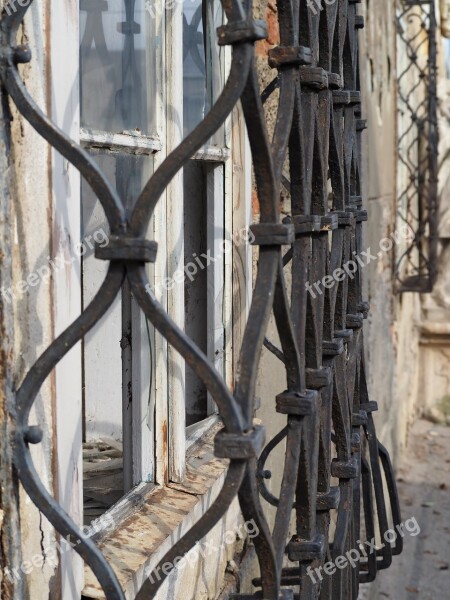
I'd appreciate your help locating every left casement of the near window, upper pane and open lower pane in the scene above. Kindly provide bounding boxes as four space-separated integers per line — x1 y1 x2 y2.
80 0 161 521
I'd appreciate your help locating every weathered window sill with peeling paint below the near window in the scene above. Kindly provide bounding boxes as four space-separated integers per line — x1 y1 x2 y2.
79 424 232 600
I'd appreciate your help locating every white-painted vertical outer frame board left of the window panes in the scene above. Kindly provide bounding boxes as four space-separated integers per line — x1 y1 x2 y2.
52 2 84 600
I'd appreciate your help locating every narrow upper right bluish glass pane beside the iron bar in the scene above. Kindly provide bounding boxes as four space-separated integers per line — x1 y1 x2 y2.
183 0 225 135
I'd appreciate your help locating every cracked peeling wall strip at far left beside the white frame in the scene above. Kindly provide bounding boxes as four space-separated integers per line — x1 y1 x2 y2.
0 3 57 599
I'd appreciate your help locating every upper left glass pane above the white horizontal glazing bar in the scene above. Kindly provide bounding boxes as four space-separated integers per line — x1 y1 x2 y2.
80 0 156 135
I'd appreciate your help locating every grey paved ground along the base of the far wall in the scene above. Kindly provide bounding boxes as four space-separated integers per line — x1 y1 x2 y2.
370 420 450 600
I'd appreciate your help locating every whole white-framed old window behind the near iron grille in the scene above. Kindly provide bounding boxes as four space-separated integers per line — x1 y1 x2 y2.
80 0 233 523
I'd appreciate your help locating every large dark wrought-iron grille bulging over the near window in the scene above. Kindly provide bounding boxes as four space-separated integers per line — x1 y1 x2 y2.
0 0 401 600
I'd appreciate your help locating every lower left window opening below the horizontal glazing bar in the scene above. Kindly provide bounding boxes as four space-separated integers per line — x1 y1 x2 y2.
80 153 153 524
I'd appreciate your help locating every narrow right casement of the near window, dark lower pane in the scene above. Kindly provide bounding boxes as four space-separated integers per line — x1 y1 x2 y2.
183 0 229 427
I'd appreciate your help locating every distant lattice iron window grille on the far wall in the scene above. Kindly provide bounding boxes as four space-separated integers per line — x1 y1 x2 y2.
395 0 439 293
